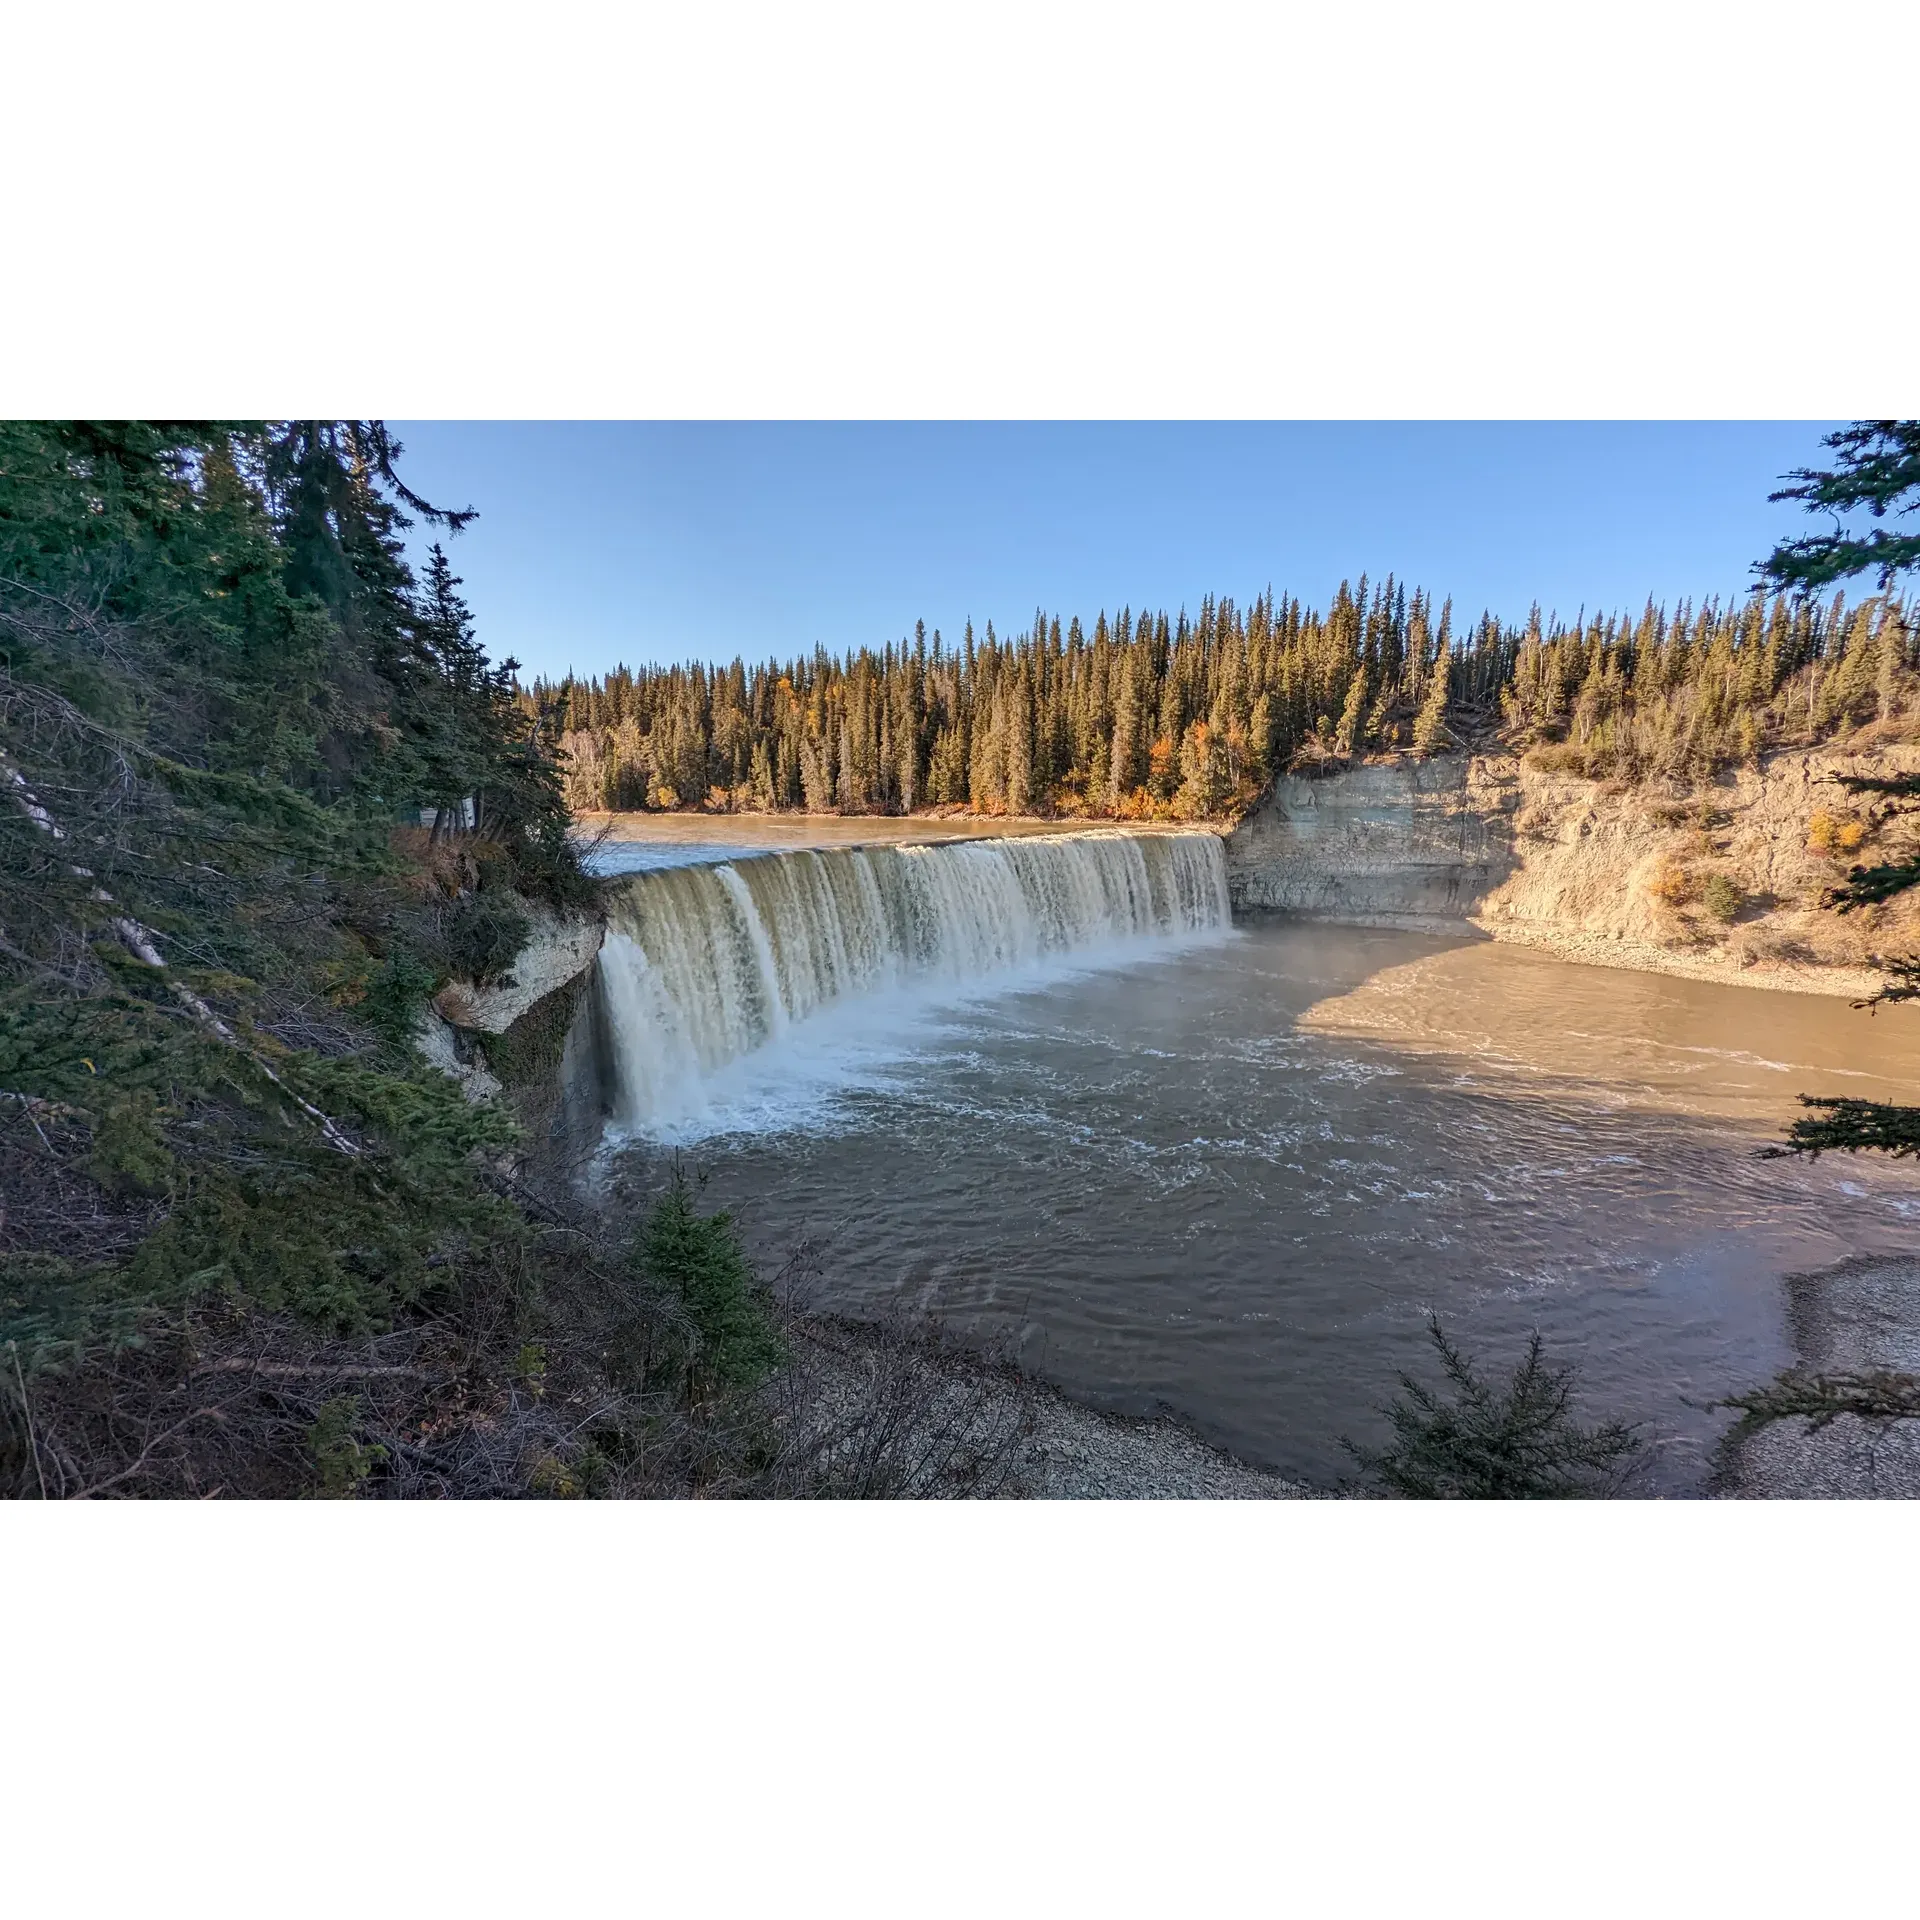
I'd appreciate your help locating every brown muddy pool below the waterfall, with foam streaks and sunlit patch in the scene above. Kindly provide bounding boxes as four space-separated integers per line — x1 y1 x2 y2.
579 817 1920 1494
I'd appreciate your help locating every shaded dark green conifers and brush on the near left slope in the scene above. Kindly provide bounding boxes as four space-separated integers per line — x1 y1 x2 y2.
0 420 817 1498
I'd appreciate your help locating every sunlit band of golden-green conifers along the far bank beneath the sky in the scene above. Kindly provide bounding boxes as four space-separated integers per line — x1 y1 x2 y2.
537 578 1920 820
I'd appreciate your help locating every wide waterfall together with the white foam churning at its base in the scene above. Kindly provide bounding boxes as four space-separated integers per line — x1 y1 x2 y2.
599 831 1231 1144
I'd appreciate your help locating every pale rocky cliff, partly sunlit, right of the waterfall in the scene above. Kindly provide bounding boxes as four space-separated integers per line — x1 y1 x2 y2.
1227 747 1920 995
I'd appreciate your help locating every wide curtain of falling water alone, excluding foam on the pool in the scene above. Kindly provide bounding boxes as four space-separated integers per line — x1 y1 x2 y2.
599 831 1229 1127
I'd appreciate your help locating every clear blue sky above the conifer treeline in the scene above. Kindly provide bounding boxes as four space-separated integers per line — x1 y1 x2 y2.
392 420 1837 676
